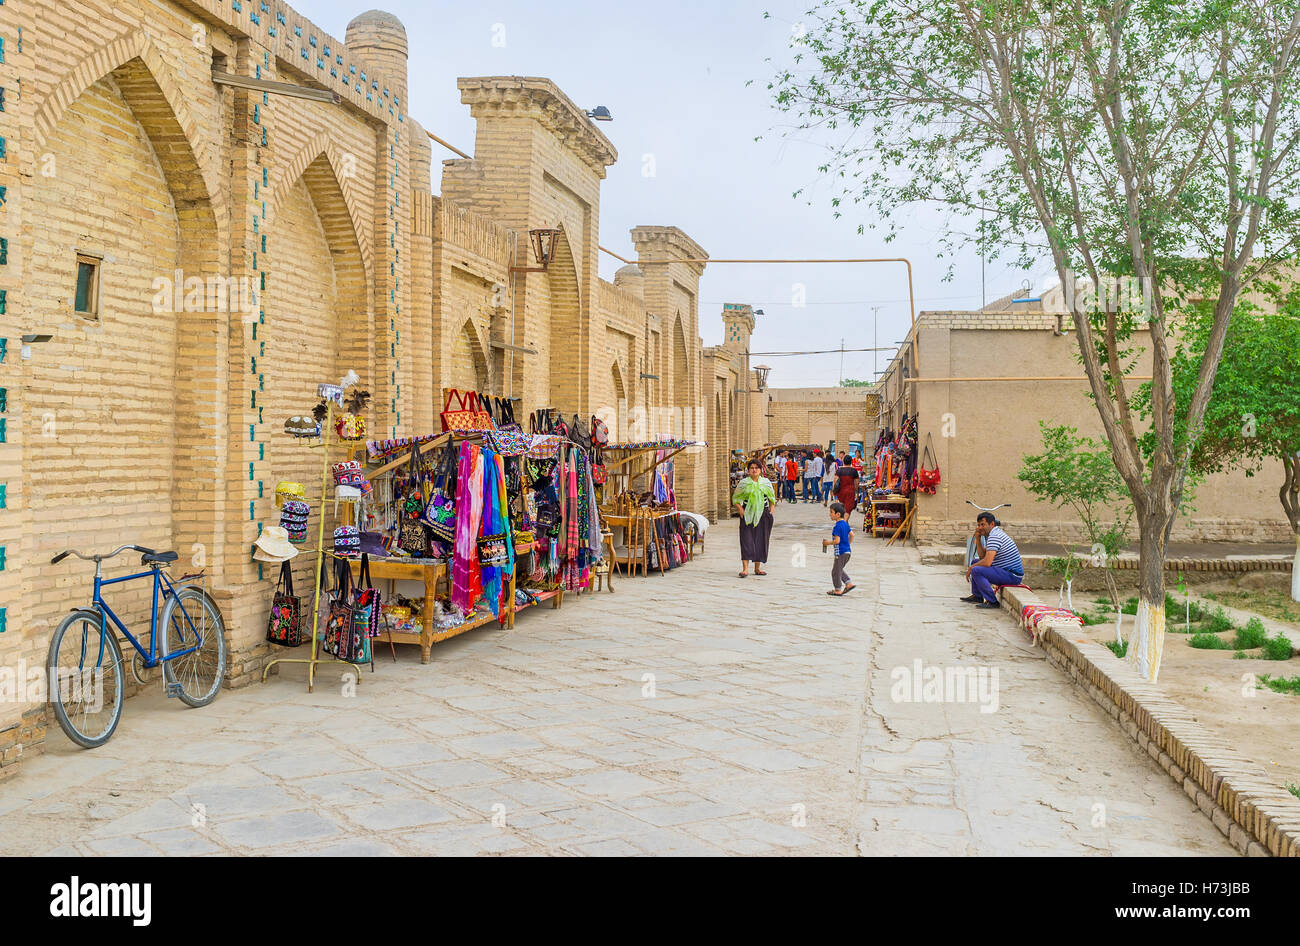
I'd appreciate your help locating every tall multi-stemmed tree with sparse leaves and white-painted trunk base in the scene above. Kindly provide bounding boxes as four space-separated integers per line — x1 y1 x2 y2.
770 0 1300 681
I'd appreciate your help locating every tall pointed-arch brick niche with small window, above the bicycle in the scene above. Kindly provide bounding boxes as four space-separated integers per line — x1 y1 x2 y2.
23 53 224 646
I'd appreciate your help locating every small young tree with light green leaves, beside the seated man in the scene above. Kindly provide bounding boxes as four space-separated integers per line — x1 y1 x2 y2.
1017 421 1132 611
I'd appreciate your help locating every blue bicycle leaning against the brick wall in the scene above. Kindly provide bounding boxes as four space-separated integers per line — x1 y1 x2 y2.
46 546 226 748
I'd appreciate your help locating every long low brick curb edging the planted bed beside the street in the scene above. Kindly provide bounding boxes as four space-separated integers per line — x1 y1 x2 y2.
1002 589 1300 858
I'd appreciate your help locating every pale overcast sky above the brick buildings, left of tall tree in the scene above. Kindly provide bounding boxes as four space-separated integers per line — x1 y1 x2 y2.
306 0 1043 387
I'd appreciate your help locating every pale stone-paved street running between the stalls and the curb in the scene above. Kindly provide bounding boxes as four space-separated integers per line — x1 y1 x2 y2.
0 504 1232 855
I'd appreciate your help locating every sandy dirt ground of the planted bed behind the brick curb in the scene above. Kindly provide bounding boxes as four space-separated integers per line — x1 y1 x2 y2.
1075 574 1300 787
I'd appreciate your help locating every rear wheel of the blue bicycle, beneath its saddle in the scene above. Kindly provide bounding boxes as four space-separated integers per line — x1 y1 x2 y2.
159 586 226 707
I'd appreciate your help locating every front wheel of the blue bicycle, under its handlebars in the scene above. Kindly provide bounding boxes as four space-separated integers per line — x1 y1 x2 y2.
46 609 124 748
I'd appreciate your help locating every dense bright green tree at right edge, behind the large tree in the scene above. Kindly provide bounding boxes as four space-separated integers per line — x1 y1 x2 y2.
1143 302 1300 602
